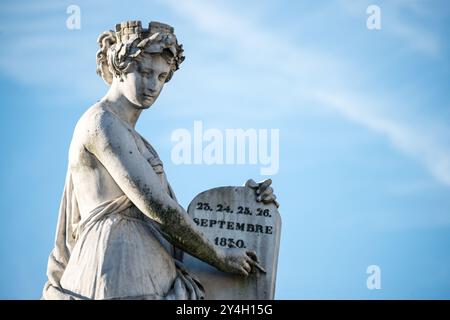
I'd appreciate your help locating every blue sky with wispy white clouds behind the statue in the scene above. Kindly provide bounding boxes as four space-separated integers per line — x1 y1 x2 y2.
0 0 450 299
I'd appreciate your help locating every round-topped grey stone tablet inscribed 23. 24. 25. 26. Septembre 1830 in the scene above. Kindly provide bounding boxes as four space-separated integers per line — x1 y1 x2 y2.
184 187 281 300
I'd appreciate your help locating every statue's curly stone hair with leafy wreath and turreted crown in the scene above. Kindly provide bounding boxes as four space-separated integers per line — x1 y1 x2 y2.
97 21 184 85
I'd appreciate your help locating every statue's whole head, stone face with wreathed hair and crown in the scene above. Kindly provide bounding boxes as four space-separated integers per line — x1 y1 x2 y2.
97 21 184 108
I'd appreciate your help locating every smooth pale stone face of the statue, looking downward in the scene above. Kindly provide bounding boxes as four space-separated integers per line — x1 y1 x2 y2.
120 54 171 109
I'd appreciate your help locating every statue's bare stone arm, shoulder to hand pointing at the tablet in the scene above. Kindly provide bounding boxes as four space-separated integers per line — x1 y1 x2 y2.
85 112 252 274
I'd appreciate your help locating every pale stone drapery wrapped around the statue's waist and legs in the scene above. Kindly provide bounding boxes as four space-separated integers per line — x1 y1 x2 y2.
42 138 204 300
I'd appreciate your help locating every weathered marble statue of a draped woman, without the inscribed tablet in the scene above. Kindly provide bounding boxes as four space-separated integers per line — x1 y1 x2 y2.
43 21 276 299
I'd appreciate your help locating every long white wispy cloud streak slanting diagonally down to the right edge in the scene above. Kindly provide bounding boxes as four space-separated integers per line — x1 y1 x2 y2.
167 1 450 186
